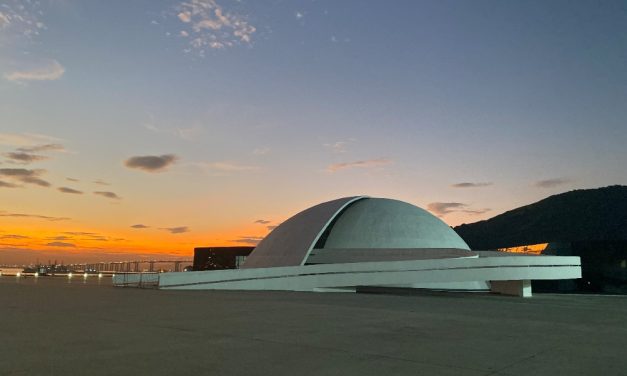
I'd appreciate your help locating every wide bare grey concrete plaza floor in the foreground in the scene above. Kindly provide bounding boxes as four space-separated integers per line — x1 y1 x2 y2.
0 276 627 376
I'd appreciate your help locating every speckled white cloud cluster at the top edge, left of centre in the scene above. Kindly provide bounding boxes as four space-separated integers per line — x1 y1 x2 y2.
176 0 257 57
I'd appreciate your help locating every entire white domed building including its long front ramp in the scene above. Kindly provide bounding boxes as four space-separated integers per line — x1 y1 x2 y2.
150 196 581 296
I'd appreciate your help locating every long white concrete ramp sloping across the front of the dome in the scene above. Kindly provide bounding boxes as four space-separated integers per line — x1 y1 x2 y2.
159 256 581 292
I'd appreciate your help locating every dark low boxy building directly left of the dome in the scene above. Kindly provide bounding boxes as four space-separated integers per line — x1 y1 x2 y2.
193 247 255 271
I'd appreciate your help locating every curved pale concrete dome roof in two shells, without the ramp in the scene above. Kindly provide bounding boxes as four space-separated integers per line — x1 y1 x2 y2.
243 196 469 268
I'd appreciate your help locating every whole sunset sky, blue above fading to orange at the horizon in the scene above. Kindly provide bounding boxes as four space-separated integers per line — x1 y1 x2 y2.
0 0 627 264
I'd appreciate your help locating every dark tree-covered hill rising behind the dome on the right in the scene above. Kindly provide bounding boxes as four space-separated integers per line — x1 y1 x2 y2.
454 185 627 249
